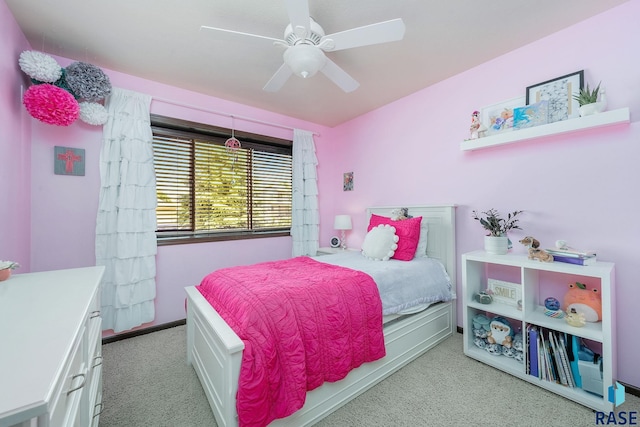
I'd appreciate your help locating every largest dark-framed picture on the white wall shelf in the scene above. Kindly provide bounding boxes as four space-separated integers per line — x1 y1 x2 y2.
526 70 584 123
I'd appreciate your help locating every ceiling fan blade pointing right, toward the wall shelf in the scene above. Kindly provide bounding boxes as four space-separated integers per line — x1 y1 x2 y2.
320 18 405 52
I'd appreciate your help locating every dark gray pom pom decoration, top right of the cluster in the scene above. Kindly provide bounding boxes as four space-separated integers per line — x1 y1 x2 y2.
65 62 111 102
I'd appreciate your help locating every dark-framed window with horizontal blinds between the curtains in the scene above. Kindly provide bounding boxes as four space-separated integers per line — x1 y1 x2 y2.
151 115 292 244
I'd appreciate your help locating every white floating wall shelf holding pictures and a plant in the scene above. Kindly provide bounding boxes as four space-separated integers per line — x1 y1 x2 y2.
460 108 630 151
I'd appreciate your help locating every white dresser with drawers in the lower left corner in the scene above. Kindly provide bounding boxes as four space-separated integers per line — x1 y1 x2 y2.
0 267 104 427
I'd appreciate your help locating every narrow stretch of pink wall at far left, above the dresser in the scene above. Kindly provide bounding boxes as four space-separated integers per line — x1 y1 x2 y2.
0 1 31 272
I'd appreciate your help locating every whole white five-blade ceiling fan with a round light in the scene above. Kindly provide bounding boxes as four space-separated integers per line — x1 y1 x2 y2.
200 0 405 92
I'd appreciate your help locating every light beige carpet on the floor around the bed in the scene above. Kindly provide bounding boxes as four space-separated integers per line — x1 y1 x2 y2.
100 326 640 427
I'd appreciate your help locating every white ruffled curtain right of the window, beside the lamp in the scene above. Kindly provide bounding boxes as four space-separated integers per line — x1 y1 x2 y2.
291 129 320 256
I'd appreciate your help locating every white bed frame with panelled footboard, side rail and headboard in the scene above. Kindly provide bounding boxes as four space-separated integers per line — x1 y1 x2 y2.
186 205 456 427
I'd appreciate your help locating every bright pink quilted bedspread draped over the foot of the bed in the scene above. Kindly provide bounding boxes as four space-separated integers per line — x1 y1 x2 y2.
198 257 385 426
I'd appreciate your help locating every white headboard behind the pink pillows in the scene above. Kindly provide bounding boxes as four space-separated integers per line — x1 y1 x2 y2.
367 205 457 287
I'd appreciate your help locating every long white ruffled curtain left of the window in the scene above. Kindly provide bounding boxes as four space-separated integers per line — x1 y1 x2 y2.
96 88 157 332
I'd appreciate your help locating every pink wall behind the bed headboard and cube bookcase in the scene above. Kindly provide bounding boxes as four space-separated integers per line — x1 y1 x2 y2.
319 2 640 386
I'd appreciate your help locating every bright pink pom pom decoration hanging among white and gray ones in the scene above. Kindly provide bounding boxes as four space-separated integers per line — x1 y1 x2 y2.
22 83 80 126
